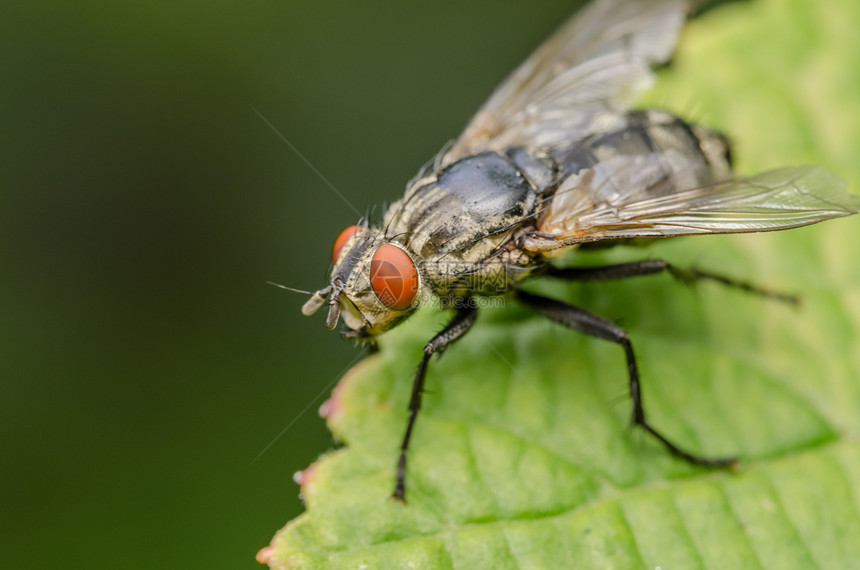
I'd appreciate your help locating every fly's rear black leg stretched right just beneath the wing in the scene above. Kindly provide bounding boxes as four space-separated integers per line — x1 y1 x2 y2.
545 259 800 305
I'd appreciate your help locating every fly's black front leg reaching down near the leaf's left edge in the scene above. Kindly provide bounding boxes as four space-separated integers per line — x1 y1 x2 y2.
391 299 478 502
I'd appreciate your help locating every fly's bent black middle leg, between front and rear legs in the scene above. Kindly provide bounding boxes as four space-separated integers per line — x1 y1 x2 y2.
517 291 737 467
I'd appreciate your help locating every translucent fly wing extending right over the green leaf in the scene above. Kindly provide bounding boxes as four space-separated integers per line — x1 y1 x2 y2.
525 161 860 251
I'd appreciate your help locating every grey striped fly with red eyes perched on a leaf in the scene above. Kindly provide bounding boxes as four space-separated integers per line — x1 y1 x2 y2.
302 0 860 500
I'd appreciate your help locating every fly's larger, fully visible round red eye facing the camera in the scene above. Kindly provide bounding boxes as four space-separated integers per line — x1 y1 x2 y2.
370 243 418 310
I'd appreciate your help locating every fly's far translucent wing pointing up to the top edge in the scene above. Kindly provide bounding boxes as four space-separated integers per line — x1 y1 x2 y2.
442 0 687 165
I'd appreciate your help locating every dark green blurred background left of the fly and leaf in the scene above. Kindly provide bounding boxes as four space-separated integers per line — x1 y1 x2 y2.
0 0 592 568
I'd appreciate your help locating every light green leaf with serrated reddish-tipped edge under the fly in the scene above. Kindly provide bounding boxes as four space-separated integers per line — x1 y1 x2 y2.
260 0 860 570
